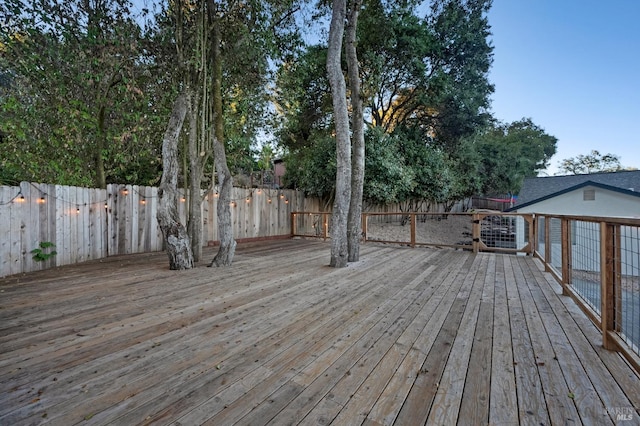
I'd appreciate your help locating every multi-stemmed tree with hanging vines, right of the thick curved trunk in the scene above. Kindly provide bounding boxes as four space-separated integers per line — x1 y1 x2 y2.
149 0 293 266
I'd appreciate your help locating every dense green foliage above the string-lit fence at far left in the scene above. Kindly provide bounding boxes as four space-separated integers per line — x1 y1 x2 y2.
0 0 156 187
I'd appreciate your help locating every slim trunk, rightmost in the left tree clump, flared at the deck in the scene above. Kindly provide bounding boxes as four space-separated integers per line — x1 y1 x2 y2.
209 19 236 266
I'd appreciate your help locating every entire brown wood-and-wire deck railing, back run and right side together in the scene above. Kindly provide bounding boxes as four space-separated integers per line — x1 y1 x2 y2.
291 212 640 371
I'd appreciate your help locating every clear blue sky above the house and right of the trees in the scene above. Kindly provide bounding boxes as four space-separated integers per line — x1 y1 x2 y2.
488 0 640 176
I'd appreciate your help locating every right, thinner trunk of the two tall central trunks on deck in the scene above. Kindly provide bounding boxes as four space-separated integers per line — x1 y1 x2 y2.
345 0 365 262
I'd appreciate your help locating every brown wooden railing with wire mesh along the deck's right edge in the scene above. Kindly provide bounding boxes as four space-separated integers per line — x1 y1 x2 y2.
535 215 640 371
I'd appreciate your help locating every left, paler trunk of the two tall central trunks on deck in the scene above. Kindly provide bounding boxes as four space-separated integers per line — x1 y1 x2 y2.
327 0 351 268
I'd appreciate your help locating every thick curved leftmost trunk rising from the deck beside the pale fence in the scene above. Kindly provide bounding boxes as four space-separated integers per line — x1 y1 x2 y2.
158 94 193 269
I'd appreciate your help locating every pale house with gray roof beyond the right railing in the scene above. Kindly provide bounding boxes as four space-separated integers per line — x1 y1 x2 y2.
506 170 640 275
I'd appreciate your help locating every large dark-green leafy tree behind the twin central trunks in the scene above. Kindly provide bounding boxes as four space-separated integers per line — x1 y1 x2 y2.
277 0 493 213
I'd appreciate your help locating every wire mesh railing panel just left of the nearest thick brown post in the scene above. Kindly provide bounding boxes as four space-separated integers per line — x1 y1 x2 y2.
569 220 601 314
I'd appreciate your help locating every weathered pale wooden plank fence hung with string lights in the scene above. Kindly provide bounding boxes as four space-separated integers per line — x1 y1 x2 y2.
0 182 320 277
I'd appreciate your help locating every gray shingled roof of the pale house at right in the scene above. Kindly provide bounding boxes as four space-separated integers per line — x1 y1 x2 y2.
514 170 640 207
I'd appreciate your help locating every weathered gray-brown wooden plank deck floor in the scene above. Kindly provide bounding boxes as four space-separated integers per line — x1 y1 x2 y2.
0 240 640 425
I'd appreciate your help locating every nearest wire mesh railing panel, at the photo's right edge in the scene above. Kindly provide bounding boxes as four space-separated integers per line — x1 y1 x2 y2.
614 226 640 354
